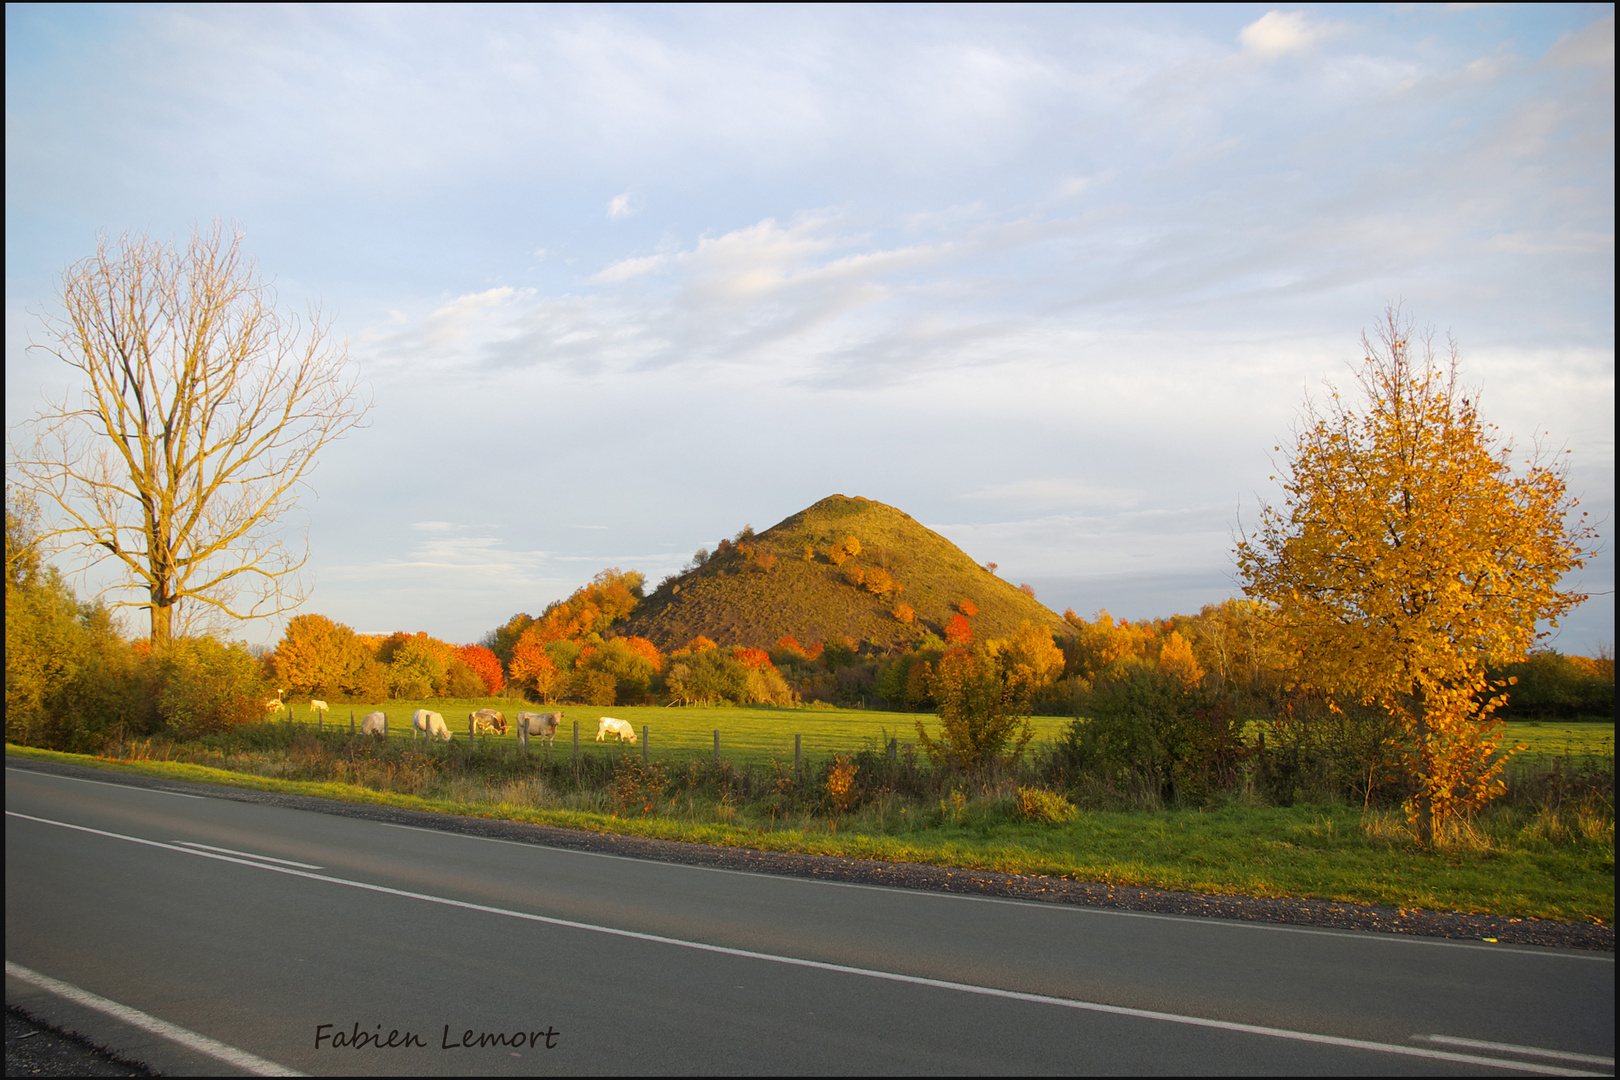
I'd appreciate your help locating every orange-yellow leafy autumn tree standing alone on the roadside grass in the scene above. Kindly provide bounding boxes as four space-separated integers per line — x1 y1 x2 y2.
1236 308 1596 844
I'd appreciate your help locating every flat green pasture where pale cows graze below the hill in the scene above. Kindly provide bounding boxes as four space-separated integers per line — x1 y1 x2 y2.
268 698 1068 766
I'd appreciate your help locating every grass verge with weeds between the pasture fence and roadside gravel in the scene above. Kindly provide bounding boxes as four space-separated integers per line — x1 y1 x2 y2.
6 735 1614 923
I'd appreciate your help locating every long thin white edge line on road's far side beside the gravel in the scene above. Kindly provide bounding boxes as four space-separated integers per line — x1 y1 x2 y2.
371 821 1615 963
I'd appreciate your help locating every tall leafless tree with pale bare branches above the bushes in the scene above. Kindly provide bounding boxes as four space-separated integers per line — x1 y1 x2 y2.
8 222 371 646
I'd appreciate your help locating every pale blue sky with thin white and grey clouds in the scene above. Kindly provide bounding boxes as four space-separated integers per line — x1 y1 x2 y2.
5 3 1615 653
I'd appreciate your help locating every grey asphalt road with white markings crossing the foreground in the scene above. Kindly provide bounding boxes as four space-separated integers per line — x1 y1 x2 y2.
6 767 1615 1075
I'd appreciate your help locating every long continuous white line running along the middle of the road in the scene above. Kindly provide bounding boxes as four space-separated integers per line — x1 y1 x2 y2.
5 810 1602 1077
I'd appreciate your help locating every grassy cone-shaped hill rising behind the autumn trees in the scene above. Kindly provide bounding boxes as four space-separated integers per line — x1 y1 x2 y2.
619 495 1064 649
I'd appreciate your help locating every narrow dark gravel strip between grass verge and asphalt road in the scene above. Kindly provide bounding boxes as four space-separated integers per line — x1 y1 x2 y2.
6 758 1615 952
